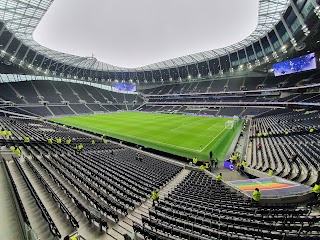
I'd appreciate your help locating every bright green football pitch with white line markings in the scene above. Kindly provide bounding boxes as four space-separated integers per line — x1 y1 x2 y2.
50 112 241 161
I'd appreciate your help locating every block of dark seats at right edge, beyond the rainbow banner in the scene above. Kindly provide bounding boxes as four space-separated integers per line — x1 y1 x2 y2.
248 110 320 185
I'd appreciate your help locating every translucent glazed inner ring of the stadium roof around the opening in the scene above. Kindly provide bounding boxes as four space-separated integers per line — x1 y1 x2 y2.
0 0 289 71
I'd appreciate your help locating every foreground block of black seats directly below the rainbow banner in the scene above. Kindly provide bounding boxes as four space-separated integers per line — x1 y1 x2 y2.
134 171 319 239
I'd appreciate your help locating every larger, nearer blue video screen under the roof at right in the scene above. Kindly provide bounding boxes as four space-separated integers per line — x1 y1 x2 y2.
273 53 317 77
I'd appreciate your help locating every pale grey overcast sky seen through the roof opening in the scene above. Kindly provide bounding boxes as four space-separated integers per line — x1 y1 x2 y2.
34 0 259 68
